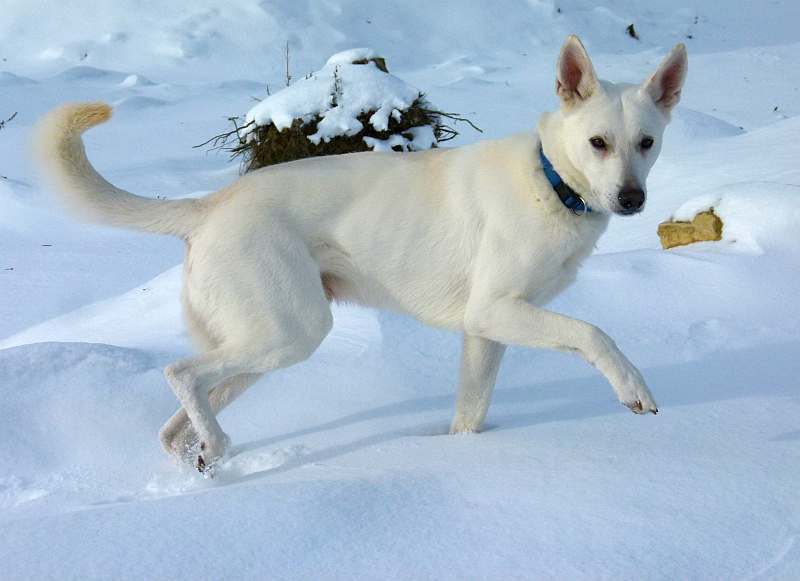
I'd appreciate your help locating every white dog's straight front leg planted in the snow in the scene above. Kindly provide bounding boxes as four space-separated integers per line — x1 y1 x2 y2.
450 334 505 434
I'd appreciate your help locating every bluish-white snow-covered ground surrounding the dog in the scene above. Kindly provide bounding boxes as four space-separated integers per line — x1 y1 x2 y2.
0 0 800 580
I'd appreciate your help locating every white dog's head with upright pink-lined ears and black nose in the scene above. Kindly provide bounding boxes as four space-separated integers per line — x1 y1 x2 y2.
556 36 687 215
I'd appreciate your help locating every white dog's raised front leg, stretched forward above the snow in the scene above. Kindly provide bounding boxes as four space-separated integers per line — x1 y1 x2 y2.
465 297 658 414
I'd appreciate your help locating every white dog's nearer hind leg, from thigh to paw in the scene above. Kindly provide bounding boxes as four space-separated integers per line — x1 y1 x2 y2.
162 229 333 469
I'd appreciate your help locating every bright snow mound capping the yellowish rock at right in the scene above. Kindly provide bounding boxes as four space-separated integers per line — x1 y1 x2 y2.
672 182 800 254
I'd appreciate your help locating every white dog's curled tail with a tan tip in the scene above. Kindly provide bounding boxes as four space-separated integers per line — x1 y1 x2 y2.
34 103 204 238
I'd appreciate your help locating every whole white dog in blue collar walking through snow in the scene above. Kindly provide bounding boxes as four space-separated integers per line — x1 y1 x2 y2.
37 36 687 471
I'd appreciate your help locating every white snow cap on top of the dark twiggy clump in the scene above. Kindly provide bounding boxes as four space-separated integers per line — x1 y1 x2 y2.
246 49 420 144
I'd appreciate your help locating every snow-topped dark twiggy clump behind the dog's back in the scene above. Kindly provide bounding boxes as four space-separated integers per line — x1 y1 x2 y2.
232 49 457 172
